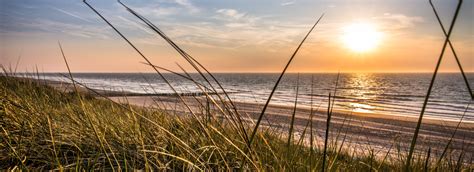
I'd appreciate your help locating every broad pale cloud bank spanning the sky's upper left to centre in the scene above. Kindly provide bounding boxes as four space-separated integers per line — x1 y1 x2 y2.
0 0 324 52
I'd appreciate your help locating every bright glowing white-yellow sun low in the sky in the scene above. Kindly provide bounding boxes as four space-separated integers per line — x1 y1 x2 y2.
342 23 382 53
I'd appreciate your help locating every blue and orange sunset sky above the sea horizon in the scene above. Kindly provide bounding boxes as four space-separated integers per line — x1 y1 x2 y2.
0 0 474 72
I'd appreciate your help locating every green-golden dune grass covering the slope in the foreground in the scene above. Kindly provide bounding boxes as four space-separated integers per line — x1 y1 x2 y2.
0 76 473 171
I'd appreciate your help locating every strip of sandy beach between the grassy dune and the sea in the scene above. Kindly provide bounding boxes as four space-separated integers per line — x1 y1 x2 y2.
27 77 474 157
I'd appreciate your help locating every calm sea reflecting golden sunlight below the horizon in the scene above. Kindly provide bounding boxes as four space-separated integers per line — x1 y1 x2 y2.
27 73 474 122
